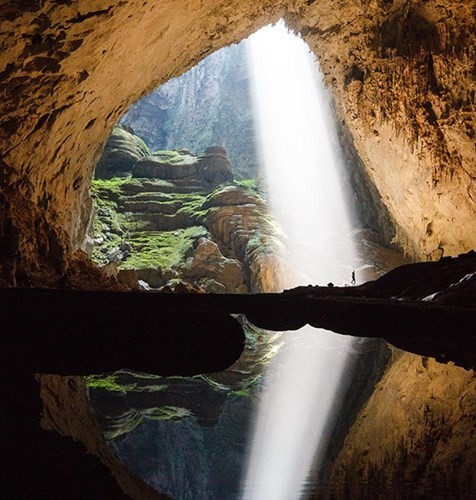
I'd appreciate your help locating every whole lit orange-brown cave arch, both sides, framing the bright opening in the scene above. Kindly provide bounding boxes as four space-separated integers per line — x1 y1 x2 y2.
0 0 476 266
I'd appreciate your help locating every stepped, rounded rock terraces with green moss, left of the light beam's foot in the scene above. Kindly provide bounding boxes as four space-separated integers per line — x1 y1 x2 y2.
90 133 286 293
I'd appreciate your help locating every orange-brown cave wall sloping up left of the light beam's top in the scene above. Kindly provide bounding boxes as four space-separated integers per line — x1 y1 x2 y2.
0 0 285 247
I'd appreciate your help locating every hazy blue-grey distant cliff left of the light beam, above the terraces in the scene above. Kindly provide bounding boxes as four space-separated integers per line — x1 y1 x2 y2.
121 41 258 179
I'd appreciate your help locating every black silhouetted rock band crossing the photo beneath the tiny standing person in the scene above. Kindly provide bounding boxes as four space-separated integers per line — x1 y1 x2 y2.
0 252 476 375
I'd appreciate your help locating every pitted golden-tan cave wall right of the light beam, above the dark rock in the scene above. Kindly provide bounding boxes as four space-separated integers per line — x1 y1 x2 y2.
291 0 476 259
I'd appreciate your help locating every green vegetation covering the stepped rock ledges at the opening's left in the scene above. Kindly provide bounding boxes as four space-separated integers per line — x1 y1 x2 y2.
91 176 207 270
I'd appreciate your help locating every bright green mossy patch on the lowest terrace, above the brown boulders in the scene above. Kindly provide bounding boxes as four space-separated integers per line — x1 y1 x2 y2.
121 226 207 270
